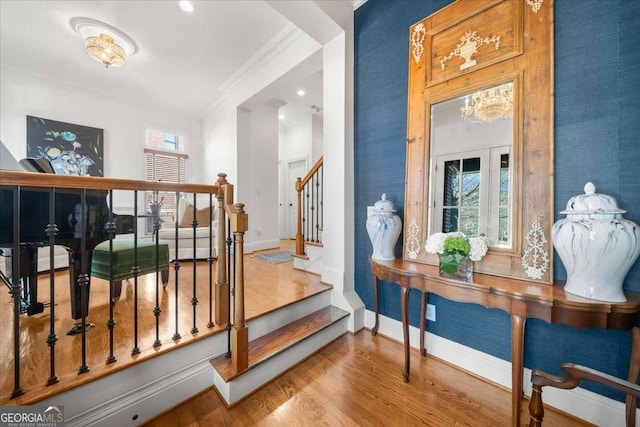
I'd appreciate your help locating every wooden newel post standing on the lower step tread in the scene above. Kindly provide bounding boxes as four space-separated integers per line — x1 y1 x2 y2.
231 203 249 373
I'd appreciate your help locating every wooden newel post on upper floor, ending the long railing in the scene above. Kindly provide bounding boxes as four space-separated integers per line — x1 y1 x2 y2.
214 173 229 325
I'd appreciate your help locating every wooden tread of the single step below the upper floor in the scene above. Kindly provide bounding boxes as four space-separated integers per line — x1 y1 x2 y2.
211 306 349 382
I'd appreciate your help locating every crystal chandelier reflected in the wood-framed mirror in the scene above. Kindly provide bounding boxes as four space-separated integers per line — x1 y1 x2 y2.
461 82 513 123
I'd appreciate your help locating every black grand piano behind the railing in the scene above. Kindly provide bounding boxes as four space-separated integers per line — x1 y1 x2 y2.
0 141 134 335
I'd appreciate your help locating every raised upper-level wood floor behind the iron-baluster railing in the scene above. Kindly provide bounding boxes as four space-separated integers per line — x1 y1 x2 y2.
0 240 330 405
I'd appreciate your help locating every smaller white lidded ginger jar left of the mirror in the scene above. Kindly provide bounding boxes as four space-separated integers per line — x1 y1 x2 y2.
367 194 402 261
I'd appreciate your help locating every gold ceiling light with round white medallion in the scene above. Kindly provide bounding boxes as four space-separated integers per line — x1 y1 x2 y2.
69 17 138 68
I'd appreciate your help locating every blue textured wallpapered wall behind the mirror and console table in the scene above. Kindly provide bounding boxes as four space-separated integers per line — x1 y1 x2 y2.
355 0 640 400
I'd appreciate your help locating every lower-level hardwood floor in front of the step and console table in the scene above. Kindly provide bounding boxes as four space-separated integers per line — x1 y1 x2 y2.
144 330 590 427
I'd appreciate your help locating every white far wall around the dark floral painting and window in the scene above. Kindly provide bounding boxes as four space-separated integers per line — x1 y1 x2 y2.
0 69 203 182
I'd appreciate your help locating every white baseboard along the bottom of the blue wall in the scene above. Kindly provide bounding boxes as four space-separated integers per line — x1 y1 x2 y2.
365 310 640 426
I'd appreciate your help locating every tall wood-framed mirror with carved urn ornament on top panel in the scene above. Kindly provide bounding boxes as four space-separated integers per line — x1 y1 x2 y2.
403 0 553 283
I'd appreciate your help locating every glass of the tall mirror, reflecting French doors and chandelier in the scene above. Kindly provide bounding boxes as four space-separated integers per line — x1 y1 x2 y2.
429 81 514 249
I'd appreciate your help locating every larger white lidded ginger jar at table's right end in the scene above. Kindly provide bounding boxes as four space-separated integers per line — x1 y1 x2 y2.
551 182 640 302
